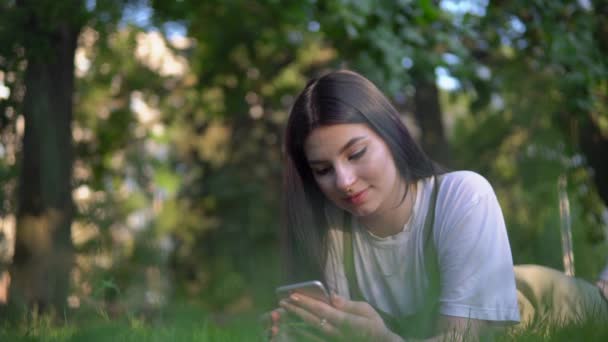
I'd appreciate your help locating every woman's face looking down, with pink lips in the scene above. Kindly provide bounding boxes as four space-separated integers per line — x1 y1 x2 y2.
304 124 404 217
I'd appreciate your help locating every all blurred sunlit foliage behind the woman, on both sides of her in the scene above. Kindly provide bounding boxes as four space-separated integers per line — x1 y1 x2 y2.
0 0 608 318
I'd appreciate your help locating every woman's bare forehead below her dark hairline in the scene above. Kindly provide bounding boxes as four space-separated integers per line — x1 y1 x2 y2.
304 124 380 159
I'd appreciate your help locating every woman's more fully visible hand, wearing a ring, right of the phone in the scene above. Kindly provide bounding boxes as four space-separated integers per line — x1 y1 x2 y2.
280 294 398 341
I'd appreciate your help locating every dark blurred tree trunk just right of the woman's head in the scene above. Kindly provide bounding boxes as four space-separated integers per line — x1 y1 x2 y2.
414 80 450 167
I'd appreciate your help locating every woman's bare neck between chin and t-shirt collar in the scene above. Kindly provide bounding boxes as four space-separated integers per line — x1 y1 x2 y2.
359 183 416 237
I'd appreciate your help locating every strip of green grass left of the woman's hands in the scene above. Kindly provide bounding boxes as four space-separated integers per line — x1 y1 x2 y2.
0 306 265 342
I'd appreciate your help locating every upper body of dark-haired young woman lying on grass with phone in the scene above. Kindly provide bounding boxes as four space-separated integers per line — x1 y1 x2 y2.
271 71 520 341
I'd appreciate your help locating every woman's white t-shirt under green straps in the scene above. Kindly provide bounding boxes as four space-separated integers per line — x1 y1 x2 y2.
326 171 520 323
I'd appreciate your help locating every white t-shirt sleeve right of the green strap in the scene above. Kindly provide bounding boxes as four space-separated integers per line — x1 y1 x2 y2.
434 173 520 324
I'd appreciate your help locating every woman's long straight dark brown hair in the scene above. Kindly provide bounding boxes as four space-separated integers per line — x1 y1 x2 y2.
281 70 439 281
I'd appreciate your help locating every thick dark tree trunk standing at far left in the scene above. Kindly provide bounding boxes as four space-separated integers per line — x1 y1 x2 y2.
11 2 80 313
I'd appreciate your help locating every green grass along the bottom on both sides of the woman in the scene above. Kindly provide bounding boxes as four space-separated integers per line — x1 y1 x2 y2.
0 305 608 342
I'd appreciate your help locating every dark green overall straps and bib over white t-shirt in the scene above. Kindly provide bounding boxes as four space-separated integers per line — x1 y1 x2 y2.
343 177 441 338
